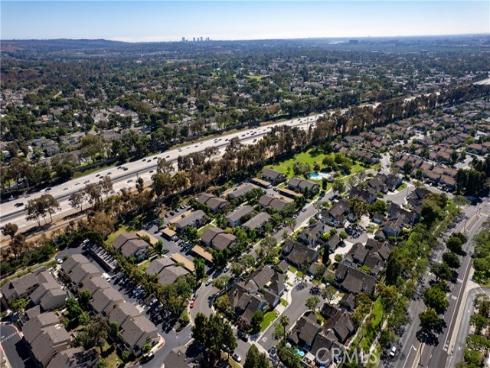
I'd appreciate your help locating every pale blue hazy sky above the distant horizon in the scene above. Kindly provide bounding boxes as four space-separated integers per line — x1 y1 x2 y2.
1 0 490 41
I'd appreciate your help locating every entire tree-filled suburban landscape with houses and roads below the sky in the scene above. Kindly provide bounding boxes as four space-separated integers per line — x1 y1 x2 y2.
0 21 490 368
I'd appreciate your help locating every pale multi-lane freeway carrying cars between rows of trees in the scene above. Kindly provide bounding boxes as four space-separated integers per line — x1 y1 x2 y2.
0 114 322 230
